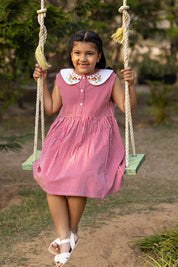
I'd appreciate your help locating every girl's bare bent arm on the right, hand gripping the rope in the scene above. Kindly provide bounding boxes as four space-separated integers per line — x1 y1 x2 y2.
112 68 137 113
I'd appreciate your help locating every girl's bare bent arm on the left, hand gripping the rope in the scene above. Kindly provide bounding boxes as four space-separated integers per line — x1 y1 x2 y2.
33 64 62 116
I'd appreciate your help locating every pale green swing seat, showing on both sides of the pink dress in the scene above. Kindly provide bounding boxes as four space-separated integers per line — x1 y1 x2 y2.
22 150 145 175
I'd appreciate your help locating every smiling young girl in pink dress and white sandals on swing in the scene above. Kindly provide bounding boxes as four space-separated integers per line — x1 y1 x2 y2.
33 31 136 267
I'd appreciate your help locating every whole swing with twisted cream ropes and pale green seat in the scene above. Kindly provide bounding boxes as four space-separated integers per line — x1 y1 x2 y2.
22 0 145 175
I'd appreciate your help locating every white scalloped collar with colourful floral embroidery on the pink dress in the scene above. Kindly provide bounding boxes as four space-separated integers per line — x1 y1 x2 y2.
60 69 113 85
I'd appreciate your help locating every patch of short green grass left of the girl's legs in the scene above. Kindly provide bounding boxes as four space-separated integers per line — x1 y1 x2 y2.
0 190 52 247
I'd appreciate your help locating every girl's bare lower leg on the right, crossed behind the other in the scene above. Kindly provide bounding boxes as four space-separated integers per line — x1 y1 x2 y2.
68 196 87 237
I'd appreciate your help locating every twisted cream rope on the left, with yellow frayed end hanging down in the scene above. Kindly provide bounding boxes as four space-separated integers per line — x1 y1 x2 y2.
34 0 50 161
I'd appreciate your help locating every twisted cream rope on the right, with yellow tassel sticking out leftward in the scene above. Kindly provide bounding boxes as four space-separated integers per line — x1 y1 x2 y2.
112 0 136 167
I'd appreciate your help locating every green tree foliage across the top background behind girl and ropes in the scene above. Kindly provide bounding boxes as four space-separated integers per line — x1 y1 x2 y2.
0 0 178 119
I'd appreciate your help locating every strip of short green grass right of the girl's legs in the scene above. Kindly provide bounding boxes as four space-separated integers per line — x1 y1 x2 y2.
82 177 177 227
